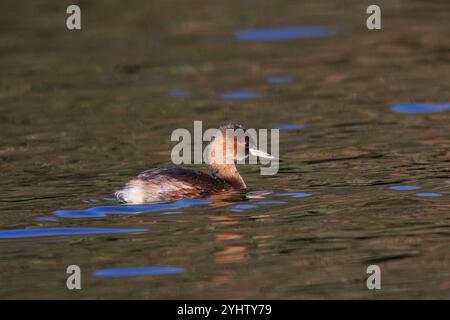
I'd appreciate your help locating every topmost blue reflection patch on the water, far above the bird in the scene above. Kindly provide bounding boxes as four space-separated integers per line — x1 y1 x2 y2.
235 26 336 41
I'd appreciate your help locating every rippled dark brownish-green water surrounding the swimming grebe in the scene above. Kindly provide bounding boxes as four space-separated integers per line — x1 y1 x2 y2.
0 0 450 299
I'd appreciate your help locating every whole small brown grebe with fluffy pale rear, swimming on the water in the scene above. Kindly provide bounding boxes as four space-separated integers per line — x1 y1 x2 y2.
116 124 273 204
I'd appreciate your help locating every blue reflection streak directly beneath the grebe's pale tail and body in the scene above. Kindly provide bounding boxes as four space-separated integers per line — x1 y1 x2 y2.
53 199 212 218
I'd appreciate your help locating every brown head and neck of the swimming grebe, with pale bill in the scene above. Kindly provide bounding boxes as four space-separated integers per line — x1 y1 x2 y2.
207 123 273 189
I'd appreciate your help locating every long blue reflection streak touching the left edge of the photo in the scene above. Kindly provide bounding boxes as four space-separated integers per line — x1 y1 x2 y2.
0 228 147 239
